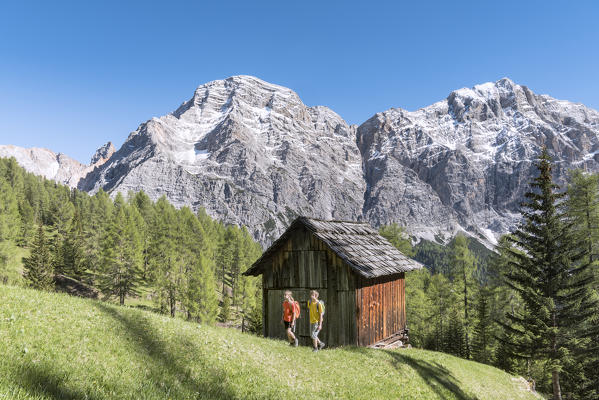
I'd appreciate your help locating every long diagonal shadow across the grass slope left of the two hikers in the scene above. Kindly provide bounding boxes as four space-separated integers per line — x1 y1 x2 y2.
94 302 236 400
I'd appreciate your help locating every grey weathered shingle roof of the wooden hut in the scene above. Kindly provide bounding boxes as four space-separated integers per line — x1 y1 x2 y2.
244 217 423 278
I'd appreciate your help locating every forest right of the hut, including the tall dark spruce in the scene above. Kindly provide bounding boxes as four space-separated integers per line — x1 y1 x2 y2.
380 152 599 400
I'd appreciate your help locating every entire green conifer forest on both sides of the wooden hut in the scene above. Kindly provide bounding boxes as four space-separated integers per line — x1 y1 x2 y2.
0 153 599 399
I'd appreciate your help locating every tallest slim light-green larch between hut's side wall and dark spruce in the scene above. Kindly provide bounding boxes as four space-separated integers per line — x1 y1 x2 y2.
451 234 475 358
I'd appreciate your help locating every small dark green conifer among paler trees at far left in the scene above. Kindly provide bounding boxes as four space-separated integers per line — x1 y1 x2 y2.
23 224 54 290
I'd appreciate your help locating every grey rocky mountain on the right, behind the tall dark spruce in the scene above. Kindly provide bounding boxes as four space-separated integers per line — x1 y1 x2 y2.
358 79 599 242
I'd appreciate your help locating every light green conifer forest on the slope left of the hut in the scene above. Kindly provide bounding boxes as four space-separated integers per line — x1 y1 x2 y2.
0 158 262 330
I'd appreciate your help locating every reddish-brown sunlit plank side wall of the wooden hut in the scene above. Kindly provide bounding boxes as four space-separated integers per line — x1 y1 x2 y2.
356 273 406 346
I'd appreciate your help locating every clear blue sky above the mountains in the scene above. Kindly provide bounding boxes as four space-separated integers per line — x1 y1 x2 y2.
0 0 599 162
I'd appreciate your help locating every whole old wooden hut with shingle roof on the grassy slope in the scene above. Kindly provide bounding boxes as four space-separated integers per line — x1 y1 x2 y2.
245 217 422 346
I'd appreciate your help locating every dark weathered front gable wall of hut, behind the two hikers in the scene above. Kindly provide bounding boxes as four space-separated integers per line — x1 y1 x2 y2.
262 229 357 346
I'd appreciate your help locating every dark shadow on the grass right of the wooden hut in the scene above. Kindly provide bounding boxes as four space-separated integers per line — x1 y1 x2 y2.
351 347 477 400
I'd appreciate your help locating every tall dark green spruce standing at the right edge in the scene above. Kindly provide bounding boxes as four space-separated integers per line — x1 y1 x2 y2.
504 149 596 400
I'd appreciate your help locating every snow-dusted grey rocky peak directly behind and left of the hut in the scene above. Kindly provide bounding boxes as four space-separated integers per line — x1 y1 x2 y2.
79 76 365 243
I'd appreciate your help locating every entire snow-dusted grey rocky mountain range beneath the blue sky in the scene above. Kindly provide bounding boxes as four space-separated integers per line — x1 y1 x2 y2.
0 76 599 245
